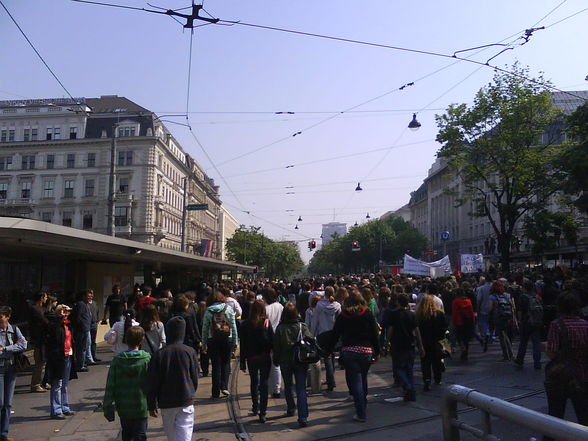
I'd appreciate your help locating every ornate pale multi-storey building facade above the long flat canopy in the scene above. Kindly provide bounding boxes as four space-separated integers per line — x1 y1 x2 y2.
0 95 234 259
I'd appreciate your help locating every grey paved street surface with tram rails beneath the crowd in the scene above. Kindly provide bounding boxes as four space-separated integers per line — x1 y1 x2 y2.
11 336 568 441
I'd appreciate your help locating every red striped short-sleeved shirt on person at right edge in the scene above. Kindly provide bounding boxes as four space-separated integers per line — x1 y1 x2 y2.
547 317 588 382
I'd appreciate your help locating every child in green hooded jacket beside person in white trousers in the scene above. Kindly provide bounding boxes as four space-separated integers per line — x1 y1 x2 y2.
102 326 151 441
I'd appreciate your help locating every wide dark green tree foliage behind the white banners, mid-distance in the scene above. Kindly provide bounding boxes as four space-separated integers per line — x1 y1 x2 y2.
308 216 427 274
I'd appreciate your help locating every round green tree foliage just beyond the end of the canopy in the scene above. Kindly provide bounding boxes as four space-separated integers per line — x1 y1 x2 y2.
226 227 304 278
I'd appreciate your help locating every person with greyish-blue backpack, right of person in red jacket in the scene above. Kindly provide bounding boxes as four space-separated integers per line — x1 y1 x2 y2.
490 281 516 361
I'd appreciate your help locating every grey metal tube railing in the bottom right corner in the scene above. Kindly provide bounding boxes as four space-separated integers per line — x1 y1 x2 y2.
441 385 588 441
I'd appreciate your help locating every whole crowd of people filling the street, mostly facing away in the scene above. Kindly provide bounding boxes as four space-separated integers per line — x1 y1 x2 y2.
0 269 588 440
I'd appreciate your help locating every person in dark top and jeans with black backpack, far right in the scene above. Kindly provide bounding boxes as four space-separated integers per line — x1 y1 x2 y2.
515 279 543 369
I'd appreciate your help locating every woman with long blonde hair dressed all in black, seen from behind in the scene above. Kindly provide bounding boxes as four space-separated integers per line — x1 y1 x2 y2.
415 294 447 391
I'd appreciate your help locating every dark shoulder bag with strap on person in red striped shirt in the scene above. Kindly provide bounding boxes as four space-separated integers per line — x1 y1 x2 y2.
544 318 586 396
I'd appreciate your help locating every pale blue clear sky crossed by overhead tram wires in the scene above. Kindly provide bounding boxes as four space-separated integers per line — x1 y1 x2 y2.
0 0 588 261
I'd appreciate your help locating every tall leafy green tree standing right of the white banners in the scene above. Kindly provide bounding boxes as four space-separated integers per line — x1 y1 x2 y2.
436 64 562 271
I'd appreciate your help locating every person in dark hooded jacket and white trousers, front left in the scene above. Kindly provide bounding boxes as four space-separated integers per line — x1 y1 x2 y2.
146 316 198 441
